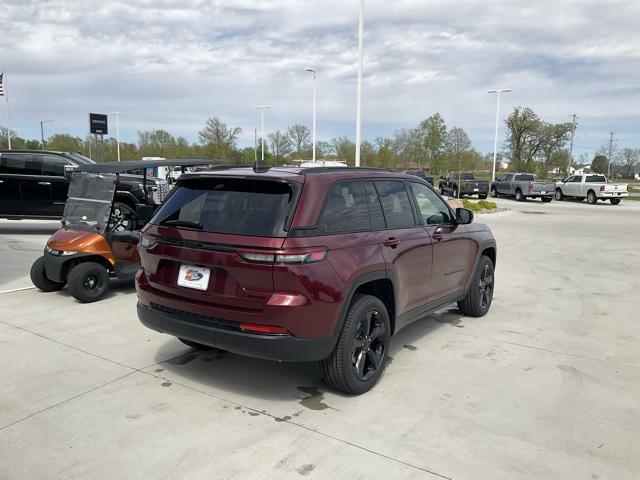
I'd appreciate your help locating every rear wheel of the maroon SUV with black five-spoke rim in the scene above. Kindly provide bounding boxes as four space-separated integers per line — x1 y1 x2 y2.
320 295 391 394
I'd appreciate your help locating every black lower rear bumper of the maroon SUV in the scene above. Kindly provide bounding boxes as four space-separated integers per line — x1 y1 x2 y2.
138 303 336 362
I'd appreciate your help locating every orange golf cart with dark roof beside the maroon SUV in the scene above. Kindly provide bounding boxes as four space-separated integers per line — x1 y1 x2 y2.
30 159 208 303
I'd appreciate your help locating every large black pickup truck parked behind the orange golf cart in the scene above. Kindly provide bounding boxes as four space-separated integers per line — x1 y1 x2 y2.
0 150 168 220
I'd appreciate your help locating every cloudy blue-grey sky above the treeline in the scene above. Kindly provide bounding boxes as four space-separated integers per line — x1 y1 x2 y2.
0 0 640 155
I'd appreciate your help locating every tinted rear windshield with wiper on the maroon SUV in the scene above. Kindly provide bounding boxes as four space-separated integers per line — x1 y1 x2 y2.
151 178 295 237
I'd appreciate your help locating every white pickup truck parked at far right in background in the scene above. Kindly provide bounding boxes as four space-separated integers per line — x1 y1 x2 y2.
556 173 629 205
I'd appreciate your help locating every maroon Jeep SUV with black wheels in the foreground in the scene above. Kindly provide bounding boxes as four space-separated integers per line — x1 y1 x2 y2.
136 167 496 393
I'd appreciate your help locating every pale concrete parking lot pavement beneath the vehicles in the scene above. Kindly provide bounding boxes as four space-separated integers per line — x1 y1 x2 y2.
0 199 640 480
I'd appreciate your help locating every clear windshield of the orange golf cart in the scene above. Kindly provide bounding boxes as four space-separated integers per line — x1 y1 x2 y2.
62 172 116 234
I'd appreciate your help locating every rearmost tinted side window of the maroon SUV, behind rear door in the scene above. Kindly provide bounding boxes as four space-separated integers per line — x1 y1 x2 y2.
317 182 371 233
